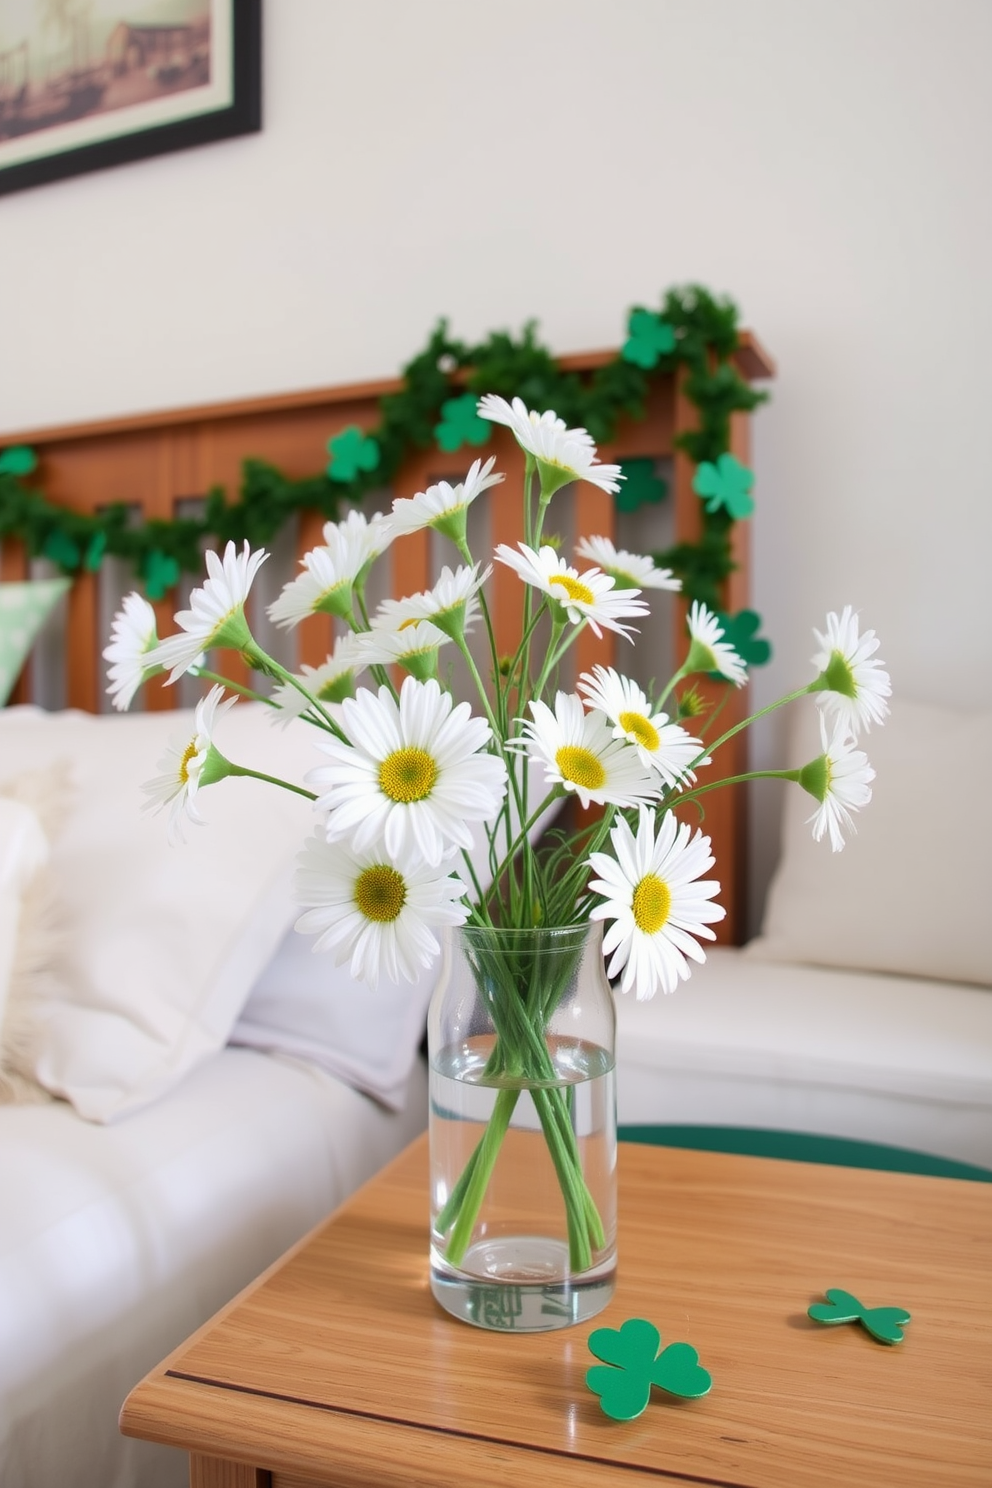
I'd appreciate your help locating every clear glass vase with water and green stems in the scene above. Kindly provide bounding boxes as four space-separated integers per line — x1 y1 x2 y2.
427 924 617 1332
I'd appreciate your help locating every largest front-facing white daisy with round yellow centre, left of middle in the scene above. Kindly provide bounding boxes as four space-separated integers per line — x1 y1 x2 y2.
306 677 507 866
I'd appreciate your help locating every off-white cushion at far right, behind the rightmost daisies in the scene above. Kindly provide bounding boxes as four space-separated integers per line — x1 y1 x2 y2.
747 696 992 987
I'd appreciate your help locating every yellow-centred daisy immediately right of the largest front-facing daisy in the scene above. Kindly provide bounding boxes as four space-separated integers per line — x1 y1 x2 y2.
518 692 660 806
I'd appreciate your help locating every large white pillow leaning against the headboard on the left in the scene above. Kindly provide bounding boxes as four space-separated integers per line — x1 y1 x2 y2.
0 704 327 1122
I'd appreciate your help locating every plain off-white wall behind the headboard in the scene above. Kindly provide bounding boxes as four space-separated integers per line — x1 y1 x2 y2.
0 0 992 916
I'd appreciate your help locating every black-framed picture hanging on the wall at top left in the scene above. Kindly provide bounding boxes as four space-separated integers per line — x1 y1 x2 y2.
0 0 262 195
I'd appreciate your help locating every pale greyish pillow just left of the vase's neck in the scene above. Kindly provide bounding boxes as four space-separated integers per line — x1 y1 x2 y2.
231 766 562 1110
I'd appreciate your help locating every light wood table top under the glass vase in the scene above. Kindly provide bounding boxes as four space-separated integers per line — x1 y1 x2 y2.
120 1137 992 1488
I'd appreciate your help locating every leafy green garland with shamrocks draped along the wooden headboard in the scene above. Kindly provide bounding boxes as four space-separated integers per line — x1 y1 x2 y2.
0 286 769 664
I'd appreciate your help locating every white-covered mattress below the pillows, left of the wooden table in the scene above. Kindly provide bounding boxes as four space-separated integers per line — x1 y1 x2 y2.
0 1049 427 1488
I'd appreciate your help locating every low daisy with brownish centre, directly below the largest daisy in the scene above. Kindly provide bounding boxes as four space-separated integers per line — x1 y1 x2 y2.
294 832 468 990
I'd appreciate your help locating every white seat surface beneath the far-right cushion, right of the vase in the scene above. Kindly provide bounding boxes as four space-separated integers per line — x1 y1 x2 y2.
617 948 992 1168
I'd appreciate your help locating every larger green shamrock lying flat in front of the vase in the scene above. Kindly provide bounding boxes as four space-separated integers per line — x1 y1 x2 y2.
586 1317 712 1421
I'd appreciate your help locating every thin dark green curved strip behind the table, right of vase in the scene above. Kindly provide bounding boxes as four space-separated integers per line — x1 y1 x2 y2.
617 1126 992 1183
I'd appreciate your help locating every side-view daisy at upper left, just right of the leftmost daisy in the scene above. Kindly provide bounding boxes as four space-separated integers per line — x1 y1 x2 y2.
146 542 269 682
